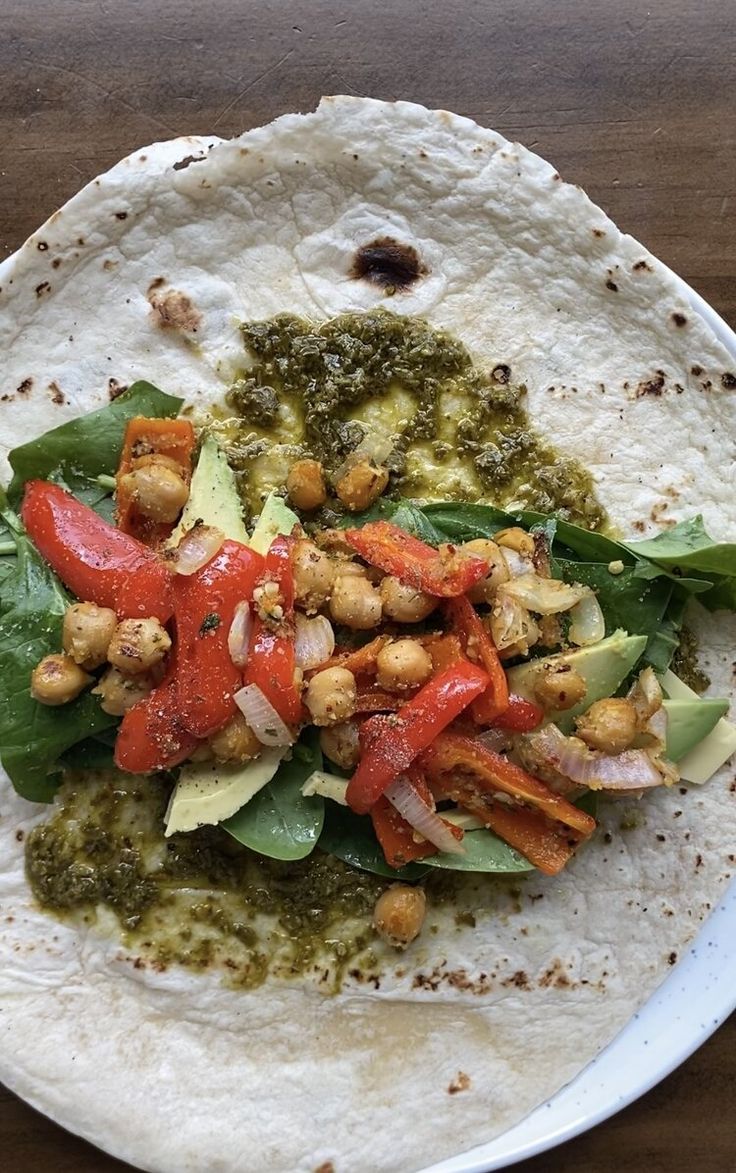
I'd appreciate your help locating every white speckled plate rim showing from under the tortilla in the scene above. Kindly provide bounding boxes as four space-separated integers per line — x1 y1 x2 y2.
425 273 736 1173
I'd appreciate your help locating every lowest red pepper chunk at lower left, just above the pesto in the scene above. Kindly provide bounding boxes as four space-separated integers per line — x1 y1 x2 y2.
115 659 198 774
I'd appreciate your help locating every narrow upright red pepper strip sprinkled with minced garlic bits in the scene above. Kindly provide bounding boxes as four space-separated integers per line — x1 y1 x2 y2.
243 535 304 725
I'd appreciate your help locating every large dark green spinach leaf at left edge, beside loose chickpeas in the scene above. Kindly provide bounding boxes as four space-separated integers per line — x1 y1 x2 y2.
0 511 117 802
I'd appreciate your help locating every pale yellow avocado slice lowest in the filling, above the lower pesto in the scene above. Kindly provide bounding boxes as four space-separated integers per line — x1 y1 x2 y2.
166 748 285 835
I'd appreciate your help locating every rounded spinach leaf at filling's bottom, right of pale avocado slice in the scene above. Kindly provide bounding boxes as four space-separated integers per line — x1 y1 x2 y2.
221 728 324 860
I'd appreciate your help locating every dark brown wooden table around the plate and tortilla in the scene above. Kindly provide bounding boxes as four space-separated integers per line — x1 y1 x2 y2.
0 0 736 1173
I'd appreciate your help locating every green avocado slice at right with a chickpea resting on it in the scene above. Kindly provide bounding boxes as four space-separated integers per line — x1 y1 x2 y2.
507 629 647 733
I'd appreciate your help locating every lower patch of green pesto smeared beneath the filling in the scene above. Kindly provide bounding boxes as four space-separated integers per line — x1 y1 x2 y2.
26 773 434 989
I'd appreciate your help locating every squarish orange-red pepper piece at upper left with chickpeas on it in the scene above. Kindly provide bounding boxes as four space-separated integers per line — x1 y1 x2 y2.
115 415 195 545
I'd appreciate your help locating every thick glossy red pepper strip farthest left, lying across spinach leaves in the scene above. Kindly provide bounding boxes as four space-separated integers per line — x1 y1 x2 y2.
21 481 174 623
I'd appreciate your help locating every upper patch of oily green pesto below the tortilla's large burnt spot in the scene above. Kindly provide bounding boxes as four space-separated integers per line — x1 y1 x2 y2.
221 310 605 529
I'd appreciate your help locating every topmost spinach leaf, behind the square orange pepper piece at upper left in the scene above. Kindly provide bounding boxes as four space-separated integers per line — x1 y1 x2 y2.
8 381 183 513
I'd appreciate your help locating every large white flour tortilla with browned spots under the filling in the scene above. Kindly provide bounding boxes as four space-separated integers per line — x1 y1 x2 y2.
0 97 736 1173
